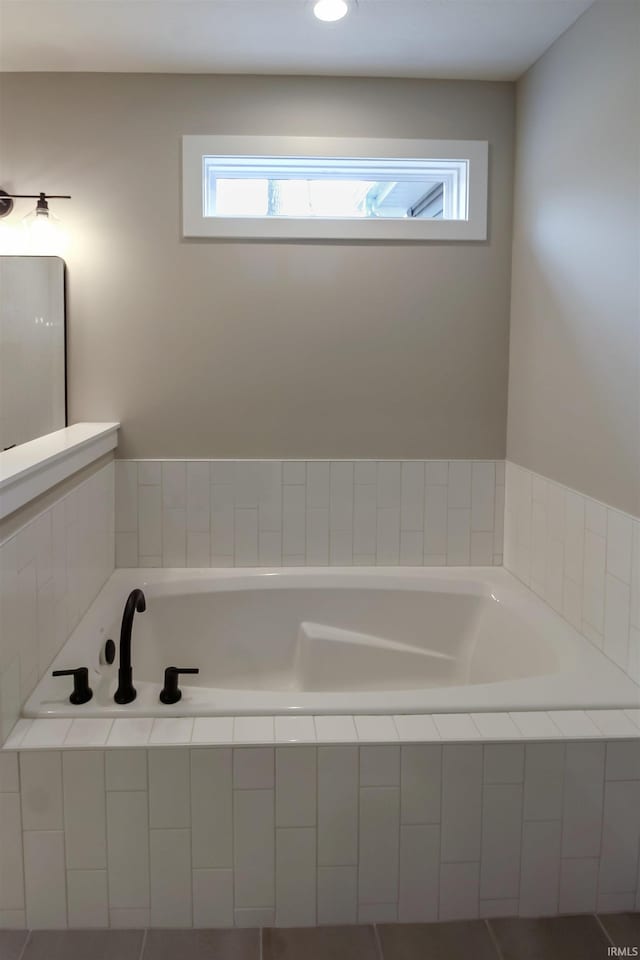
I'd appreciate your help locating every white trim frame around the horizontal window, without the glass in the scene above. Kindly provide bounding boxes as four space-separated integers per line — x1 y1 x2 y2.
182 135 489 242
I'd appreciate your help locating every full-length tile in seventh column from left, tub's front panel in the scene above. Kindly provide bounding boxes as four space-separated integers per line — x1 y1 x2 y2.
233 790 275 907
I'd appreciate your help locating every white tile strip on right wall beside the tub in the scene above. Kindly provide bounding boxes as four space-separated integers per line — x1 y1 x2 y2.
504 462 640 684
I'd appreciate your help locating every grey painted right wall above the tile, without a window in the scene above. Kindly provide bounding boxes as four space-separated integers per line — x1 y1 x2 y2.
507 0 640 515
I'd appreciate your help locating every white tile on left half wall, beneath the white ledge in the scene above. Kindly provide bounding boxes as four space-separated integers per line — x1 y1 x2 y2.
0 463 115 743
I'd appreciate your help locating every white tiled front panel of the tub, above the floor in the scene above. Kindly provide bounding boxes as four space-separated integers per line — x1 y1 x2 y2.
0 737 640 929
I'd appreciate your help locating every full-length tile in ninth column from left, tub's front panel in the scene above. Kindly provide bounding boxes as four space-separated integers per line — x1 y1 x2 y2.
318 745 358 866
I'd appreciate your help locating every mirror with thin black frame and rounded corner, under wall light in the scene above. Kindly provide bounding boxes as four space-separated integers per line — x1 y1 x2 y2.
0 256 67 450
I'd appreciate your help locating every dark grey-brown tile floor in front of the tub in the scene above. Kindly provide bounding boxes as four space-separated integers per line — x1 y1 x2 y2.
0 913 640 960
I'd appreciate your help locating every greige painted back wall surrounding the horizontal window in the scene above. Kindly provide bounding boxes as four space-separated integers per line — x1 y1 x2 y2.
0 74 515 458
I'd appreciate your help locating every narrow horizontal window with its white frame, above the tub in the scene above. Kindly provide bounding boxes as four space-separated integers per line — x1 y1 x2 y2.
183 136 487 240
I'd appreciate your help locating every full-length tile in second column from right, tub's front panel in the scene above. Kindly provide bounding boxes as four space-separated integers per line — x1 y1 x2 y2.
562 741 605 858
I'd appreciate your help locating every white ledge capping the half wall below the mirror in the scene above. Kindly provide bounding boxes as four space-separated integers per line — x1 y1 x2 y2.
0 423 120 520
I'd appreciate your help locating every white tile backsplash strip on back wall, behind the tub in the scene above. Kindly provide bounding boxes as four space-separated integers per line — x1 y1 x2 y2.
116 460 504 567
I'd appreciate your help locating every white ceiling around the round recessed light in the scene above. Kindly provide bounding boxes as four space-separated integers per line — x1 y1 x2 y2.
0 0 592 80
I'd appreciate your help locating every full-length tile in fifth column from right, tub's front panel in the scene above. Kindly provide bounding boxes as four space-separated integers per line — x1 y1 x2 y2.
441 744 482 863
